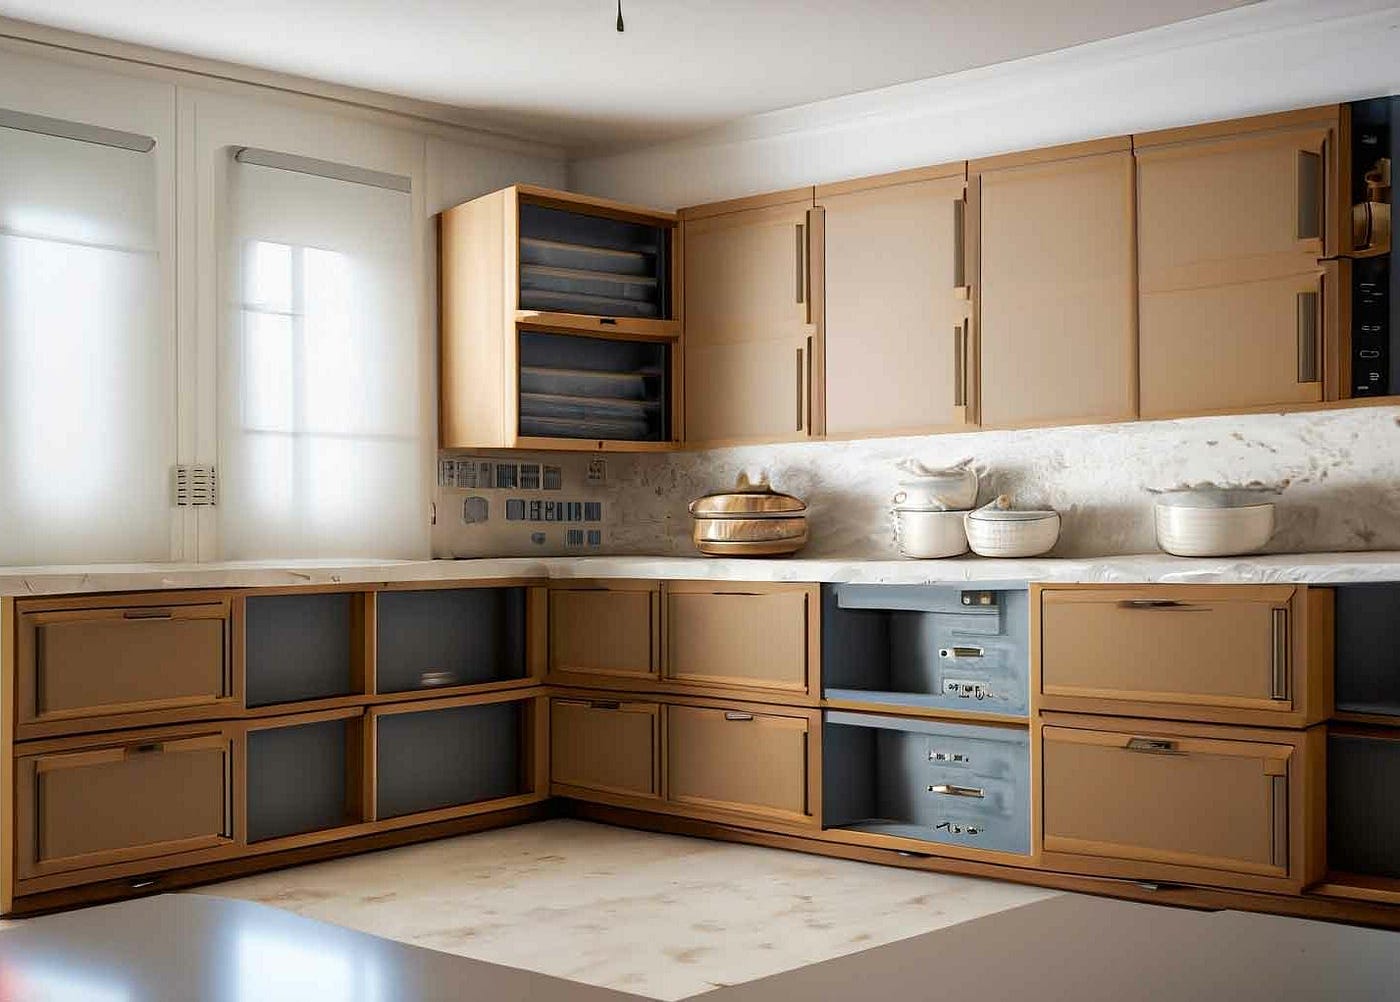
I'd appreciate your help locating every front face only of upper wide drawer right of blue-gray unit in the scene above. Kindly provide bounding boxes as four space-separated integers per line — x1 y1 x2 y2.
1040 588 1295 712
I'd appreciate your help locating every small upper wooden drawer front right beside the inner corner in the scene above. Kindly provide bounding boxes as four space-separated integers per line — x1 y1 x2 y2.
549 588 659 676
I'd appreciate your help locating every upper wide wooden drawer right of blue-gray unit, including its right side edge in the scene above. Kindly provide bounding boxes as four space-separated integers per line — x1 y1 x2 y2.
1033 585 1331 726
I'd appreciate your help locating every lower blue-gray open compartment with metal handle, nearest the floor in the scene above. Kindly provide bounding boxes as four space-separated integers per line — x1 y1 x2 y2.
822 711 1030 854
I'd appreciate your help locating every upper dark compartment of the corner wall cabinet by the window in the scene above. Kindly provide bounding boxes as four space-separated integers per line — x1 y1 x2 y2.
519 199 672 320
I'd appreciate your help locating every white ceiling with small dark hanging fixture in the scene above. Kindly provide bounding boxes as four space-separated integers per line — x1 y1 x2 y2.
0 0 1252 151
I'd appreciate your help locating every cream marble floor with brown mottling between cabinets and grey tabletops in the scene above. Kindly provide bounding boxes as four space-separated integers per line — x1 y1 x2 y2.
199 820 1054 999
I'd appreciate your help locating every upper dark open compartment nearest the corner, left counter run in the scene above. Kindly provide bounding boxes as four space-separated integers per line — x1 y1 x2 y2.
375 586 526 693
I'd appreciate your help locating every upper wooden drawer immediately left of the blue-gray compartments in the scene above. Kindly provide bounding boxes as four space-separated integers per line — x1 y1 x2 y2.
664 582 820 694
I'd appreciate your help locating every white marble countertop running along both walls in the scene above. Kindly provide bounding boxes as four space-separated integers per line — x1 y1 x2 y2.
8 550 1400 596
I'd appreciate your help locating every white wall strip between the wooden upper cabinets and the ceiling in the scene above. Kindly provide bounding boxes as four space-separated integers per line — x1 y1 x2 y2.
570 0 1400 209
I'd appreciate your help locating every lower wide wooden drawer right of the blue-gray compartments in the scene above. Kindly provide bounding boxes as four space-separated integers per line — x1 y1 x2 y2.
1040 718 1324 890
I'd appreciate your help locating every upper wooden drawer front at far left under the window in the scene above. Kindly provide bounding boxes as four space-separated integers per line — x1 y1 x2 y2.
18 603 231 722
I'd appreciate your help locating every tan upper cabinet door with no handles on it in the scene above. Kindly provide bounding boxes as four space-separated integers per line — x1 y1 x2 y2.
969 139 1137 427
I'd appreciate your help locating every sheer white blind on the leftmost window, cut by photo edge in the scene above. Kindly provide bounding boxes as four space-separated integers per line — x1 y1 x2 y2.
0 121 175 565
